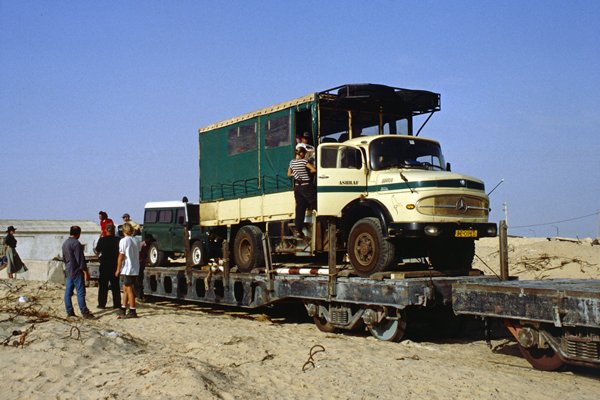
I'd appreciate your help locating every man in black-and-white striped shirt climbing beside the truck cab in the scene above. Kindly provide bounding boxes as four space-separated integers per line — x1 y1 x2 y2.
288 147 317 239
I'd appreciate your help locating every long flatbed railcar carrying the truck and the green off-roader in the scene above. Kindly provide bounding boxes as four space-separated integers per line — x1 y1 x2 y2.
144 266 498 341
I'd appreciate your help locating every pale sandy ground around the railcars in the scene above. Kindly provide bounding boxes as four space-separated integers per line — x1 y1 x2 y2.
0 238 600 399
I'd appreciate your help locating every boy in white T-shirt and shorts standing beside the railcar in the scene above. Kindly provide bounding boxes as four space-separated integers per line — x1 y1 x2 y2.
115 223 140 318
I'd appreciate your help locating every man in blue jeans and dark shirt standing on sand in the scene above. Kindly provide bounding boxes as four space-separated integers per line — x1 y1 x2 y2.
62 225 94 319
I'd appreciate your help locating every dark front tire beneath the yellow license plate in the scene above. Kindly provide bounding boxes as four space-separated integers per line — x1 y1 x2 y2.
429 239 475 272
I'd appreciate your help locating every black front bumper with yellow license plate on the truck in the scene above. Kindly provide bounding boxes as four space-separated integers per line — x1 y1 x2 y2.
387 222 498 239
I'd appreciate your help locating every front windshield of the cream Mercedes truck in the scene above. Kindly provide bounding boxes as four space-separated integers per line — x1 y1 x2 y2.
369 136 446 171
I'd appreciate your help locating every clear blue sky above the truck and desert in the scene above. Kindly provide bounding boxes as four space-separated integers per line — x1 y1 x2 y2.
0 0 600 237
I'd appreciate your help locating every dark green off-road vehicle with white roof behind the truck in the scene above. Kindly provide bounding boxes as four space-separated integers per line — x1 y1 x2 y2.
142 201 205 267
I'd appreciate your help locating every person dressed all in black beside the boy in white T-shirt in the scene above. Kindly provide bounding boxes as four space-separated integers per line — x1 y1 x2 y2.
94 224 121 309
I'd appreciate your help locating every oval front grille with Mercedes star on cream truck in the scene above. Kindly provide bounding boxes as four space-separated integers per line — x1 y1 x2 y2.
417 195 489 218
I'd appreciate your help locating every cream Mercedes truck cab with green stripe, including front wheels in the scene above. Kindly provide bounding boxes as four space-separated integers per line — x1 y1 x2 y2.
317 135 496 276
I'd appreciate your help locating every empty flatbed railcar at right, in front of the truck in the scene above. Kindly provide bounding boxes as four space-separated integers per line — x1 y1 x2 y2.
452 279 600 371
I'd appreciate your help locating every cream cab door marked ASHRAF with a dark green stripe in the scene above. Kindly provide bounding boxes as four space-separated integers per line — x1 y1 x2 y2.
317 143 367 216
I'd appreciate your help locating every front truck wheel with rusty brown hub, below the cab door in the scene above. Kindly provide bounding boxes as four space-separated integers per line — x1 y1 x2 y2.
348 217 395 277
